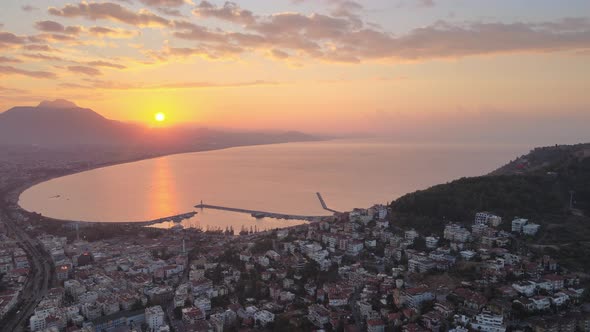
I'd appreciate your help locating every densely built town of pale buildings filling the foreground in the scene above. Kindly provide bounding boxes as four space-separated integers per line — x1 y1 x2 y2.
0 198 590 332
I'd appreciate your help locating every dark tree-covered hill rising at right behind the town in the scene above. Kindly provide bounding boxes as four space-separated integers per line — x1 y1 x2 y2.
390 144 590 270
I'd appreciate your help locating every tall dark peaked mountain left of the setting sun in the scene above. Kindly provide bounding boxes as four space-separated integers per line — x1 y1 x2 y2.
0 99 139 146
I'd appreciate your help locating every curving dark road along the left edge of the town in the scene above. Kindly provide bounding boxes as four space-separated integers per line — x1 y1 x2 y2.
0 207 53 332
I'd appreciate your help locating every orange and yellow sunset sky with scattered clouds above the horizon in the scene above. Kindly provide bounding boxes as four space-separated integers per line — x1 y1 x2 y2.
0 0 590 143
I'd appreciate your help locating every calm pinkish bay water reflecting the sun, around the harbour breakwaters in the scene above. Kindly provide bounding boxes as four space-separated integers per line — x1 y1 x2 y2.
20 139 529 231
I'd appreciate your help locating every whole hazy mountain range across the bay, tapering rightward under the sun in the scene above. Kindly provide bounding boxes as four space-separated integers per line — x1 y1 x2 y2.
0 99 317 150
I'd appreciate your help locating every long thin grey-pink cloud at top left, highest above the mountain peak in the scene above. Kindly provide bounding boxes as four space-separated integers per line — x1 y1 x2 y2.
48 2 169 27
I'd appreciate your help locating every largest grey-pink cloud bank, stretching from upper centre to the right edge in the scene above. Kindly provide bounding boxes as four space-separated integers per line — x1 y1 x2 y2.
166 5 590 63
